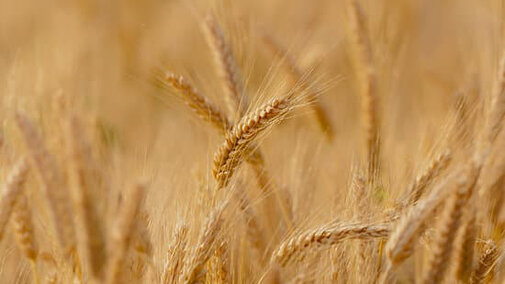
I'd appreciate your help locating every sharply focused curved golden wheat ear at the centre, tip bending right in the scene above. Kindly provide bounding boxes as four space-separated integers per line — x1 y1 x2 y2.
213 96 304 188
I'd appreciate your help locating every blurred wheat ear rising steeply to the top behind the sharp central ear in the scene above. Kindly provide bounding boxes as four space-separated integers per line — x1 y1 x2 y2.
204 14 246 119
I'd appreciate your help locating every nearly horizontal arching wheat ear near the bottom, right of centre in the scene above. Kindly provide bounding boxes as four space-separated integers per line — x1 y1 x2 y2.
272 224 391 266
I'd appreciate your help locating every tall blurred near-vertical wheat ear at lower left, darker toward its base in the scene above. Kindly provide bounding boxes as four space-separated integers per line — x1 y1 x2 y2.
67 116 107 279
